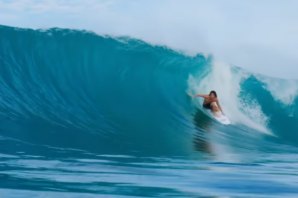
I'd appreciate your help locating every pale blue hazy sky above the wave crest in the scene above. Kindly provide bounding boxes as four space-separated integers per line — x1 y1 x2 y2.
0 0 298 79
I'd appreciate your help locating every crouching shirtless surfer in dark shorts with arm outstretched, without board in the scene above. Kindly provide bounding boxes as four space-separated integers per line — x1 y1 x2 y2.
195 90 223 116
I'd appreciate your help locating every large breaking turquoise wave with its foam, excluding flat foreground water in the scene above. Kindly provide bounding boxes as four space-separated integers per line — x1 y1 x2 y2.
0 26 298 154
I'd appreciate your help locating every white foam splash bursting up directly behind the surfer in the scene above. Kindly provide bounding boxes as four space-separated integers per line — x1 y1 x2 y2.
188 62 271 134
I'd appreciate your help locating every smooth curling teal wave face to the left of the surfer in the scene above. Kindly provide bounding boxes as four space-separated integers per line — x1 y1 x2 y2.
0 26 206 155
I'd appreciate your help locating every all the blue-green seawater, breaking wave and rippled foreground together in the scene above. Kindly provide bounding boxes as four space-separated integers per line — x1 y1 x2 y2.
0 26 298 198
